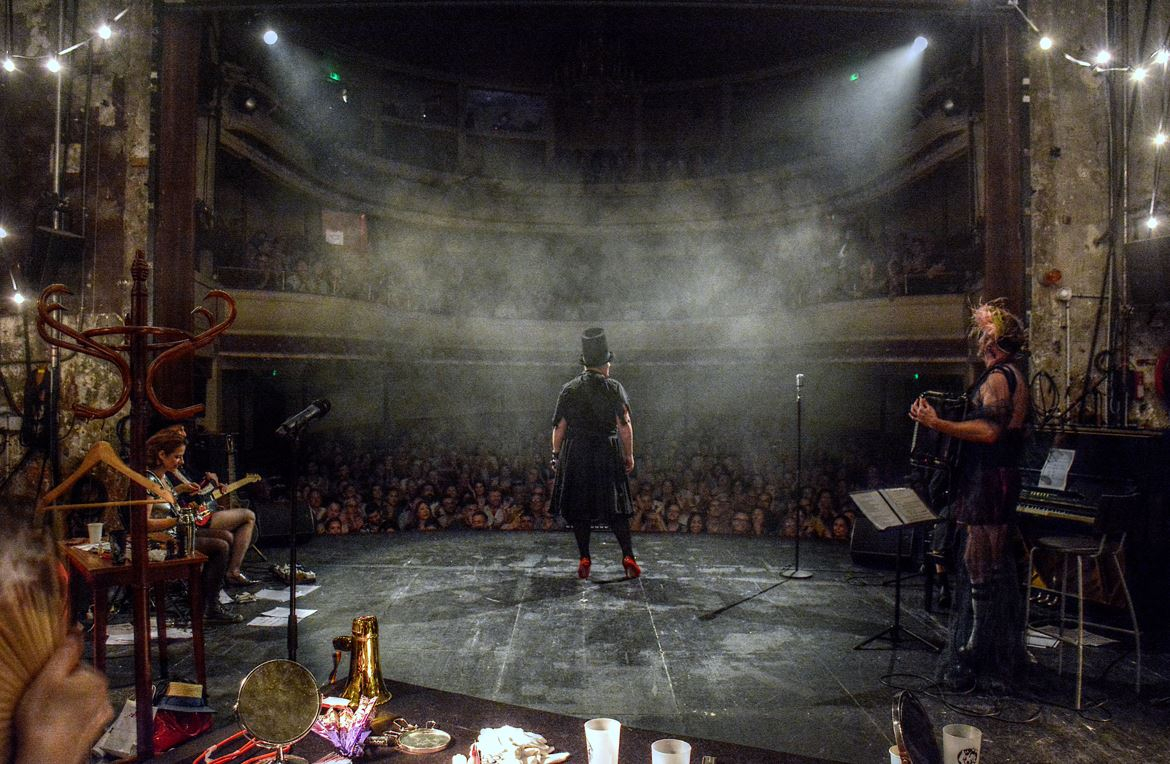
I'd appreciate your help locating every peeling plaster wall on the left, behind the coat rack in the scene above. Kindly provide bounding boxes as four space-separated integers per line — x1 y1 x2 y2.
0 0 153 509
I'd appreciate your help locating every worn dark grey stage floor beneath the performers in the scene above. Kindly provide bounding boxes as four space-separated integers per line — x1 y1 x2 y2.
98 532 1170 764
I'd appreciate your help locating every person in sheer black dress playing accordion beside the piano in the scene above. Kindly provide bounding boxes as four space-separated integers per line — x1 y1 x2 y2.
910 302 1030 689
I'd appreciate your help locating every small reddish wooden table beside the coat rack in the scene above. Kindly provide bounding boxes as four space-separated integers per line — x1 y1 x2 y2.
60 542 207 687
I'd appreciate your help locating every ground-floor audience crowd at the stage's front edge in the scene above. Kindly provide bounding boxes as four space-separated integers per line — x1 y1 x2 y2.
297 417 904 543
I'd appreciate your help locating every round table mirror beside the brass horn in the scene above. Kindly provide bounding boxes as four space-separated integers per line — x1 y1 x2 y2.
235 660 321 762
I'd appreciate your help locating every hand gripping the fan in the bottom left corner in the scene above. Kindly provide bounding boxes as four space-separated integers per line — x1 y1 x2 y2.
13 634 113 764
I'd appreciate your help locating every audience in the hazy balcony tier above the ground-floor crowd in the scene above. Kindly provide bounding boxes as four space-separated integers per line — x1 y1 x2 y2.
205 214 982 321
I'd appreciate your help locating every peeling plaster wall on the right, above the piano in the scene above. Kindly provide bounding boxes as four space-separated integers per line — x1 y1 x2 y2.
1025 0 1170 427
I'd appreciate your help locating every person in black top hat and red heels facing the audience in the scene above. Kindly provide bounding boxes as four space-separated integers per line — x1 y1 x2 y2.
552 328 642 578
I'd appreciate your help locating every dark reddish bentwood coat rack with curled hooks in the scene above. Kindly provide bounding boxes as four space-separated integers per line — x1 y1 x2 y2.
36 250 235 760
